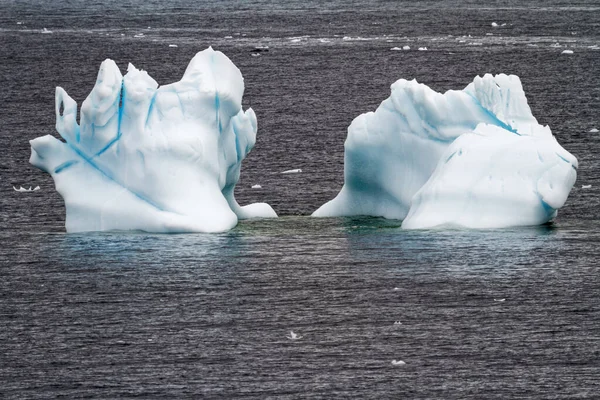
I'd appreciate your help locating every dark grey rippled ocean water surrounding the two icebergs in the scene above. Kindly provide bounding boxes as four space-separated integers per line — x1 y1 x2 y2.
0 0 600 399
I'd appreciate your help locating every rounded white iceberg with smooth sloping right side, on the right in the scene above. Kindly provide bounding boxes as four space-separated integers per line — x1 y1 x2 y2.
313 74 577 229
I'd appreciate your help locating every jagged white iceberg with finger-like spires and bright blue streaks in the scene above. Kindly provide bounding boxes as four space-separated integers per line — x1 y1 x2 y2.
30 48 277 232
